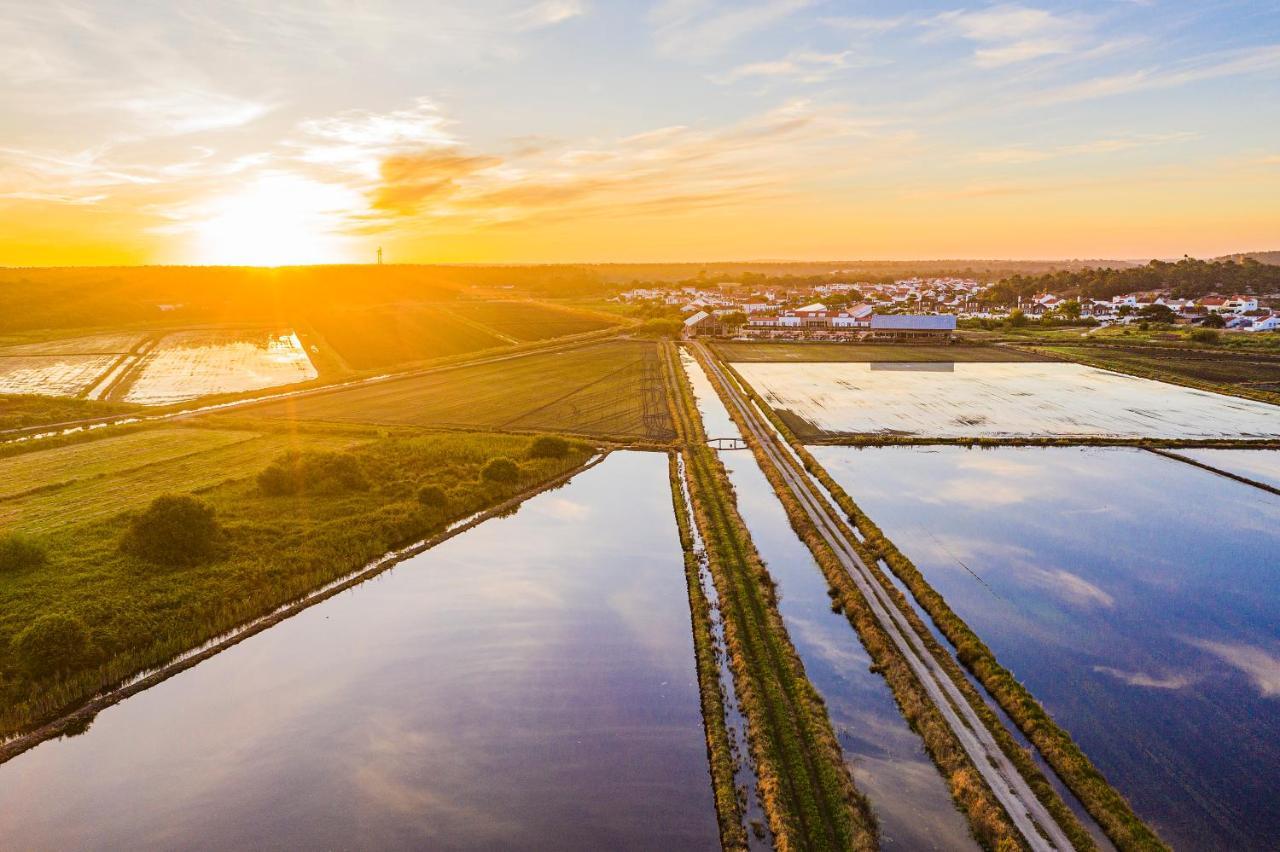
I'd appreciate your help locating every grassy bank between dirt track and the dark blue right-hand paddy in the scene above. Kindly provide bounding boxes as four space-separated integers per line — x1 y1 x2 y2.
728 355 1167 852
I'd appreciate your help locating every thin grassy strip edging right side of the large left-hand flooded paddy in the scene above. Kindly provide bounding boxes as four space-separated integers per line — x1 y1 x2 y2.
669 453 748 852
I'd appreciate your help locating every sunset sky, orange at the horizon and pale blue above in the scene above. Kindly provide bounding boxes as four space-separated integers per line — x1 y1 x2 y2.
0 0 1280 266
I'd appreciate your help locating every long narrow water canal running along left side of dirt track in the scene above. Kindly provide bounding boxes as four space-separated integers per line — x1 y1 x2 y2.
684 353 977 849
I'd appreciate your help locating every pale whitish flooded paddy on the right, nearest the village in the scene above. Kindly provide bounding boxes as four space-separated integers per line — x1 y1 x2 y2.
735 362 1280 439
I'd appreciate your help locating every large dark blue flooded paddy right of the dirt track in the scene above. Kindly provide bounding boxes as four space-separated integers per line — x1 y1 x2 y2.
814 446 1280 849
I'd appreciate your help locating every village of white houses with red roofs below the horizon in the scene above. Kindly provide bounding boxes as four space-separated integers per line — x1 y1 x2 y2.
616 278 1280 342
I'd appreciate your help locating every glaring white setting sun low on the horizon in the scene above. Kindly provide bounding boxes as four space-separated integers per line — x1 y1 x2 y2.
193 174 357 266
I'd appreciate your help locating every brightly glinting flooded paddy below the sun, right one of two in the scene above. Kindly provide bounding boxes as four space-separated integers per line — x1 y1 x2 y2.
124 330 319 406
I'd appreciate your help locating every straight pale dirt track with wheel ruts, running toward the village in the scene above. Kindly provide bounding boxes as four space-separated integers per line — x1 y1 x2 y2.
690 342 1073 851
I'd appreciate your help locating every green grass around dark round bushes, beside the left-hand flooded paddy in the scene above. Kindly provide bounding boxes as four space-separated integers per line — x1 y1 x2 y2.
0 423 595 736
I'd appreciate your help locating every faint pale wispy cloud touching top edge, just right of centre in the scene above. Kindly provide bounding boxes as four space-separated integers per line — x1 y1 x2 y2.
649 0 810 58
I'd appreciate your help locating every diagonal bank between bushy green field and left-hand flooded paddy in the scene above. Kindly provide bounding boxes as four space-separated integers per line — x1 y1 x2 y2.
0 452 609 765
